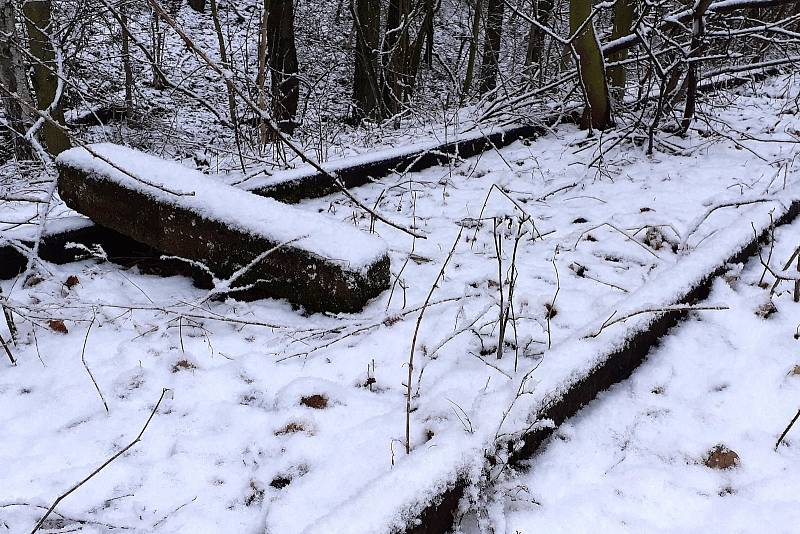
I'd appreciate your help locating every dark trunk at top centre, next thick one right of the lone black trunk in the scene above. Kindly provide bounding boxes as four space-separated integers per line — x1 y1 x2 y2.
350 0 383 120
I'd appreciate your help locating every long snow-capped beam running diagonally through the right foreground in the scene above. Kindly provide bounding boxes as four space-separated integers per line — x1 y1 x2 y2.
303 191 800 534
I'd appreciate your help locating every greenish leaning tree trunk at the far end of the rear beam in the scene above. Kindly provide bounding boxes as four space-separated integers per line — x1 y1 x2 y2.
569 0 611 130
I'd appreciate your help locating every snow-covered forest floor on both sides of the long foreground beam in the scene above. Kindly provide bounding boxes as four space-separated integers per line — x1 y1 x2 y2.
0 77 800 534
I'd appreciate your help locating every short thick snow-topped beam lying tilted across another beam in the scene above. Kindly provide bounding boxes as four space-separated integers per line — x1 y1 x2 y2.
57 144 389 312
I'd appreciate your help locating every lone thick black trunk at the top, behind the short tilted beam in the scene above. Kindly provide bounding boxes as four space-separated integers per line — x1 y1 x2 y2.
267 0 300 132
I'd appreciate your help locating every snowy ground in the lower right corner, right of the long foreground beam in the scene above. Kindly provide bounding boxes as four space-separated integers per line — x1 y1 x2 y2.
482 220 800 534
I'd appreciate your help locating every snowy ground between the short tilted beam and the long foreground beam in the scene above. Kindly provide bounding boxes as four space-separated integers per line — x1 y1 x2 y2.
0 79 800 534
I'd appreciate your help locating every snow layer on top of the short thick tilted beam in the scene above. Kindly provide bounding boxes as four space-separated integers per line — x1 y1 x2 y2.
57 143 386 270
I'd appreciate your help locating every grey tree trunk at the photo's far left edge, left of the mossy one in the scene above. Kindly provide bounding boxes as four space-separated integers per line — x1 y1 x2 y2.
0 0 33 159
